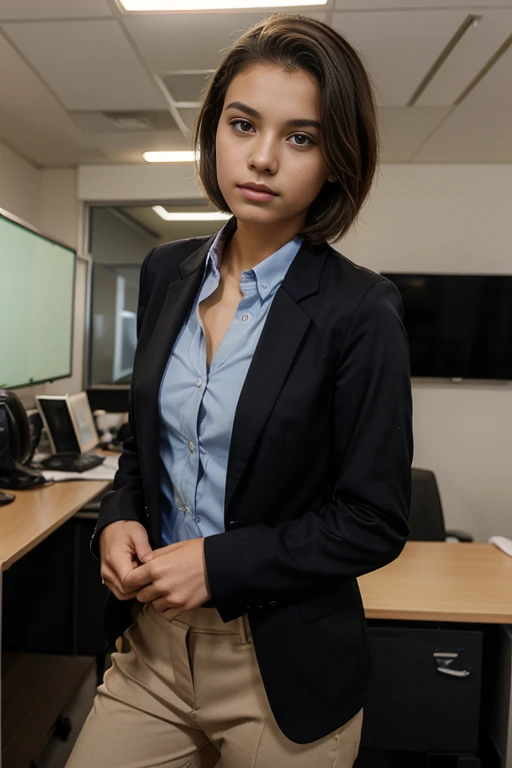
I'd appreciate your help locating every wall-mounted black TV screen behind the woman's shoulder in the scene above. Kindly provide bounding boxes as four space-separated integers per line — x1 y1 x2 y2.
382 272 512 379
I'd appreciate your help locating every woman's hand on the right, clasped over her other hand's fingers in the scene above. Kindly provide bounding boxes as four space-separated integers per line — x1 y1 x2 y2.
123 538 210 620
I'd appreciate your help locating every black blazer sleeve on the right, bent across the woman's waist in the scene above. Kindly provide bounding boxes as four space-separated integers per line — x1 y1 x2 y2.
204 278 413 622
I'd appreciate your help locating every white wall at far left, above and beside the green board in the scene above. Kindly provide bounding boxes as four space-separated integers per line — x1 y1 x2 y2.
0 144 87 408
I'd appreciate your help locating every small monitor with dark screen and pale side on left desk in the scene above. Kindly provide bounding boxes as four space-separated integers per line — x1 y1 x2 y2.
36 392 99 453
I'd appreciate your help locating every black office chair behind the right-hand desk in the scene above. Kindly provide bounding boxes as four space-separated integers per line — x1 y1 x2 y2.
409 467 473 542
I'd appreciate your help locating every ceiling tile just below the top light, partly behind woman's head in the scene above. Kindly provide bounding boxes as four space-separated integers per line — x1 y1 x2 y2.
124 10 326 74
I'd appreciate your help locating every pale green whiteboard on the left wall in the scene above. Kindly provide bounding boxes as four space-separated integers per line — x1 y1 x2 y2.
0 211 76 389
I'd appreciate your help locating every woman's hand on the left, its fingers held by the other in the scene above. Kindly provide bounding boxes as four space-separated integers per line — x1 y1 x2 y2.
100 520 153 600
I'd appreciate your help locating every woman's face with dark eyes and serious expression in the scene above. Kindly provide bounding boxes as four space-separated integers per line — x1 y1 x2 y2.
216 64 335 231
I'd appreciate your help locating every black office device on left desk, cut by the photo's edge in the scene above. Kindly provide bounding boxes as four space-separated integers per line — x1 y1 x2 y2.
0 389 46 490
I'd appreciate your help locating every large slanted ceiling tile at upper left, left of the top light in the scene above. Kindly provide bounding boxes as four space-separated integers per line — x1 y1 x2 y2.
2 20 166 110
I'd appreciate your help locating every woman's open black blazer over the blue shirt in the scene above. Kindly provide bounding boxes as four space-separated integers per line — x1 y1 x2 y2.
91 218 413 743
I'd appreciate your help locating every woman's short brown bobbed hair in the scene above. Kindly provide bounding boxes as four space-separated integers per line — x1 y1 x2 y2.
193 13 378 244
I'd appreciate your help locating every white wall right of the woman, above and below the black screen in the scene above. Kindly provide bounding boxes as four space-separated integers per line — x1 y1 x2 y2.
335 165 512 541
